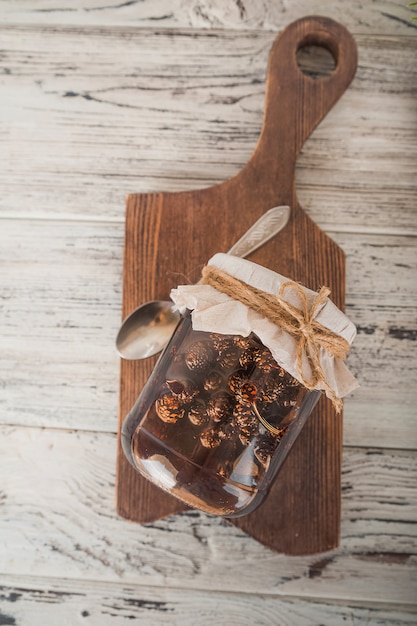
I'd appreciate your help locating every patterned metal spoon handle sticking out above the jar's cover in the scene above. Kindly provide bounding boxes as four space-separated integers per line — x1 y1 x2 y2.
228 205 290 258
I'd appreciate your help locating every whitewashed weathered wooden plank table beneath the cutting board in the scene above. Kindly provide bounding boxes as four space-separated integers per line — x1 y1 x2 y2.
0 0 417 626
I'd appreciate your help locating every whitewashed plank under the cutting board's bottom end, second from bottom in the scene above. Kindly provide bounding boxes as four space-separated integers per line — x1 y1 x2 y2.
0 427 417 606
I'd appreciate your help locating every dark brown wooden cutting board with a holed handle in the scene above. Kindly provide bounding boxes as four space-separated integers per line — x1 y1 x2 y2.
116 17 357 554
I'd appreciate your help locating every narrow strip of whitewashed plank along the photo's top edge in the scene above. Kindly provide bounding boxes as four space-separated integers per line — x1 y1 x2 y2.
2 0 415 34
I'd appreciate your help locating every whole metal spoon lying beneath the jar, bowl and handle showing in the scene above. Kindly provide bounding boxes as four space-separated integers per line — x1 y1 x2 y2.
116 206 290 360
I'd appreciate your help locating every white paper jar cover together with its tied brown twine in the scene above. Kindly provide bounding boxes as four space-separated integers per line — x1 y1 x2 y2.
171 253 358 411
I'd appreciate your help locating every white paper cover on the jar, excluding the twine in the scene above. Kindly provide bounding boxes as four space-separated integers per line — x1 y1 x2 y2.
171 253 357 398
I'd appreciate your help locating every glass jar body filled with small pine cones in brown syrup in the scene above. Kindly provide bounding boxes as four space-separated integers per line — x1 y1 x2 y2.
122 312 320 517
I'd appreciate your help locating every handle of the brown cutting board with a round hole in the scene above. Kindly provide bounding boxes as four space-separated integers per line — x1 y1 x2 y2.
244 17 357 203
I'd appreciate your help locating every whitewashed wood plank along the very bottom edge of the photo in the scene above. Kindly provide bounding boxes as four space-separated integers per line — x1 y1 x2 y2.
0 576 415 626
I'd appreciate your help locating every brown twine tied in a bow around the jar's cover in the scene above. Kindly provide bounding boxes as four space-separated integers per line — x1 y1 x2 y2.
200 265 349 412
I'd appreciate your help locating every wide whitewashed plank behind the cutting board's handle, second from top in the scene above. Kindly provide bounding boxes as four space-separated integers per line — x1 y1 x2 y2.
0 26 417 232
